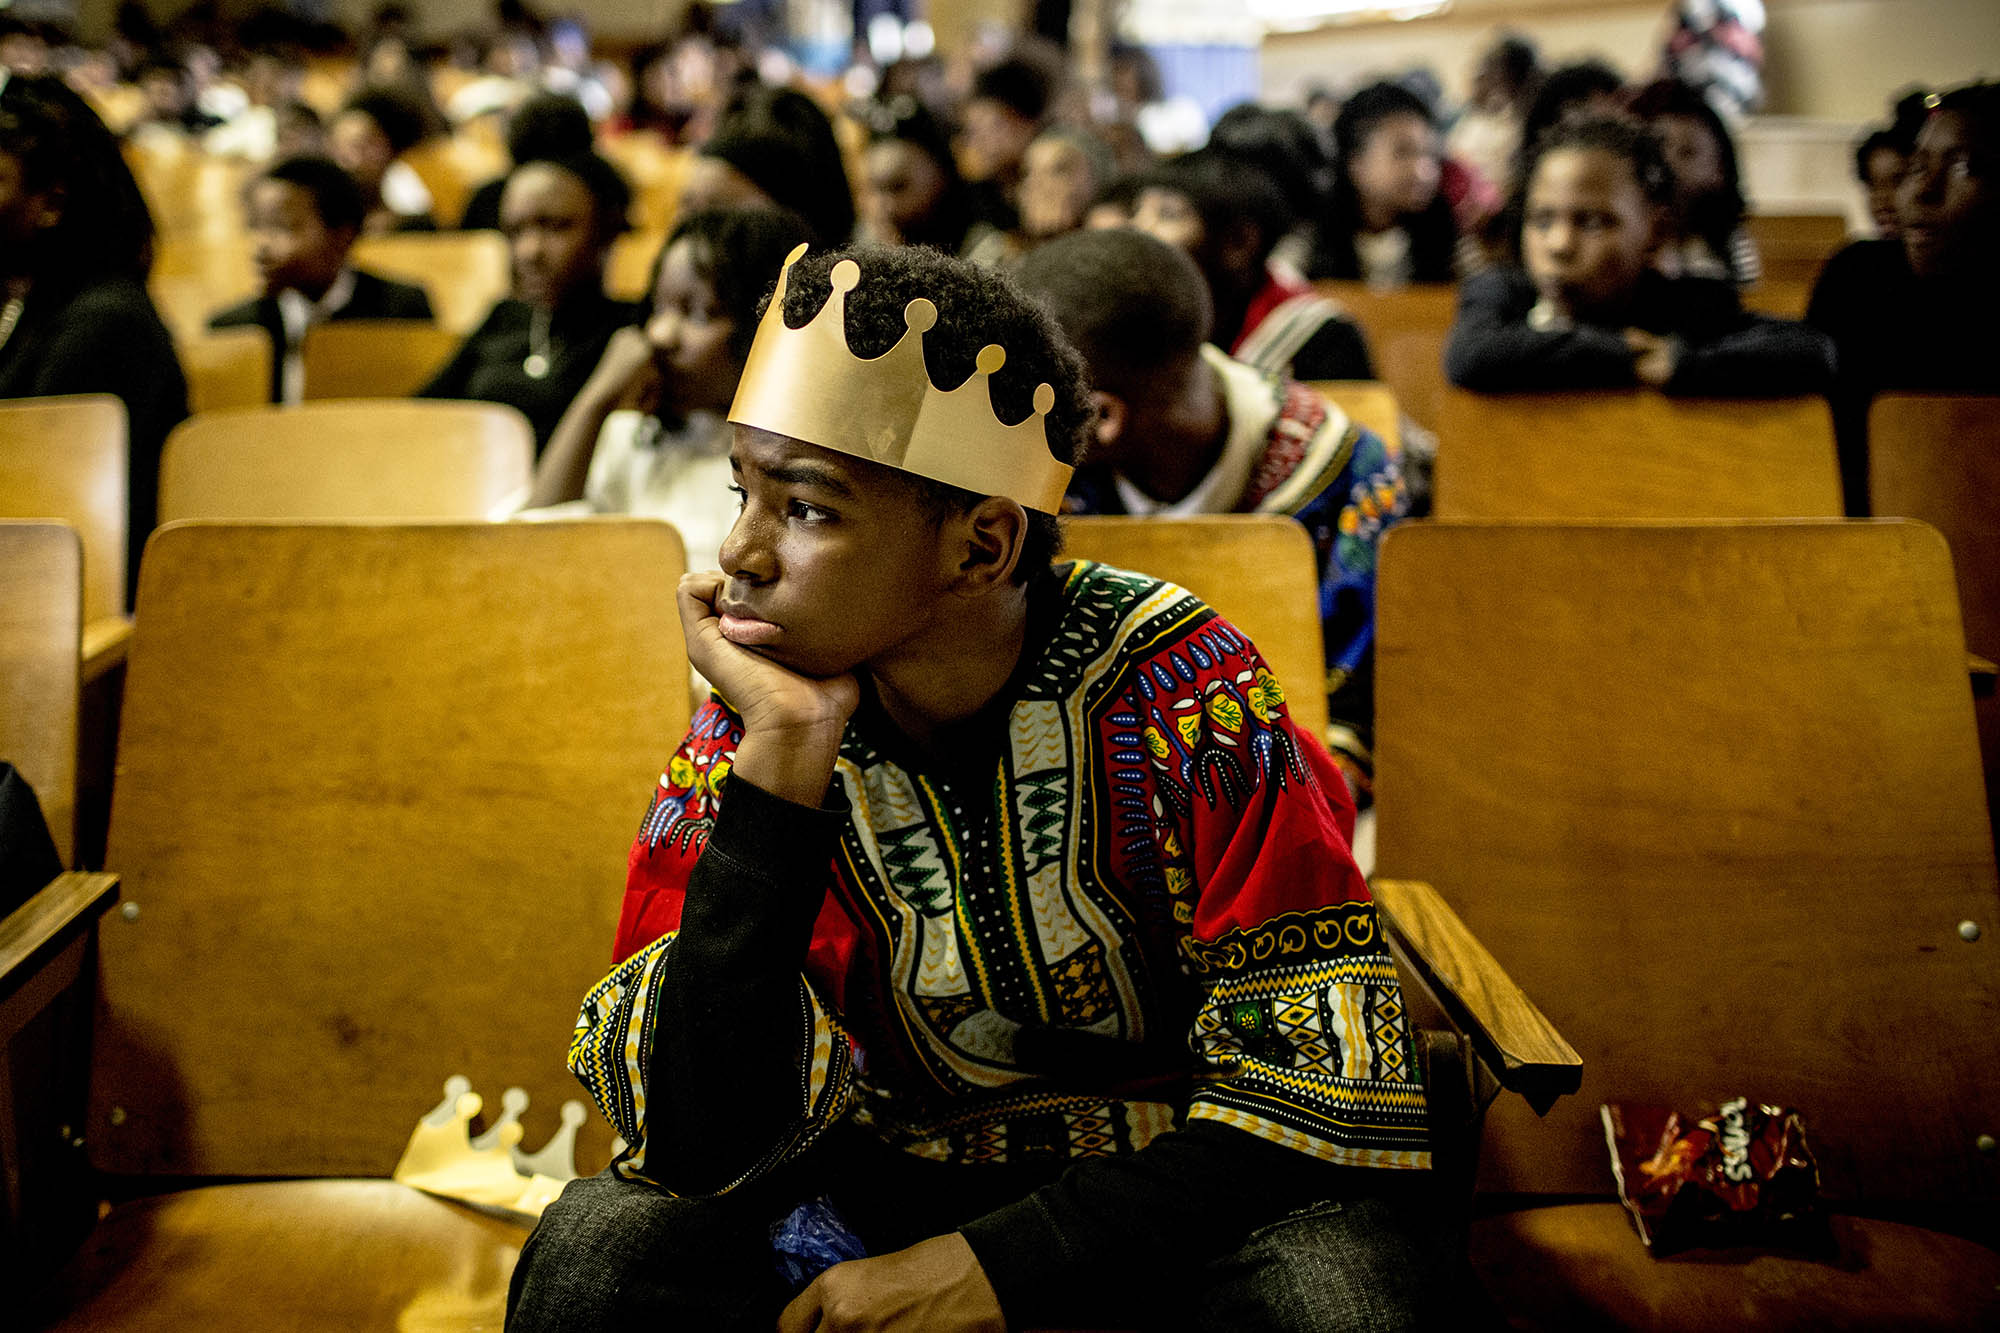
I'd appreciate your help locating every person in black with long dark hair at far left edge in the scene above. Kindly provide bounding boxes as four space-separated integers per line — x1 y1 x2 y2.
0 76 188 596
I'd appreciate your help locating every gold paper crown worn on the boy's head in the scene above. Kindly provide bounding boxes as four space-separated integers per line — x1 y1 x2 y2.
730 246 1072 514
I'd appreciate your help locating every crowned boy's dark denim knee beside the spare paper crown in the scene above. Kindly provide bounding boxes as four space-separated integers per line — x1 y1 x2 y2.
508 1173 784 1333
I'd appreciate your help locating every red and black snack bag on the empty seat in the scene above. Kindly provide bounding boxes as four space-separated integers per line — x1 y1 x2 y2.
1602 1097 1832 1257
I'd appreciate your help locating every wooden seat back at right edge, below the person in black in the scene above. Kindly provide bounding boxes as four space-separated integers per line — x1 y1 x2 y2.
1868 394 2000 827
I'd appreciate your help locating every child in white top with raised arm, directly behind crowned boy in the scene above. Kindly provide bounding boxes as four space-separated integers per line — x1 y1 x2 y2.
528 208 810 568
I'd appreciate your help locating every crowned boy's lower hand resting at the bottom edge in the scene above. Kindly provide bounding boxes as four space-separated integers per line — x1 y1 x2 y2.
778 1231 1006 1333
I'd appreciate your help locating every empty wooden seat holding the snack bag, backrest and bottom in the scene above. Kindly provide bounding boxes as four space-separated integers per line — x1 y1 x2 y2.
1376 520 2000 1329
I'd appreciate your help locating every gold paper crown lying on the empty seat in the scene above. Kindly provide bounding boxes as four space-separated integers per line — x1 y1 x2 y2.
390 1075 622 1221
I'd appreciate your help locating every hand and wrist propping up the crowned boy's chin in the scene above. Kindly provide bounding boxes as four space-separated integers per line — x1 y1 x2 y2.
678 570 862 807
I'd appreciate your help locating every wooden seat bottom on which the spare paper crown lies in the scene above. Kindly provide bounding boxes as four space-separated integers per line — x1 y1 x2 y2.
44 1181 528 1333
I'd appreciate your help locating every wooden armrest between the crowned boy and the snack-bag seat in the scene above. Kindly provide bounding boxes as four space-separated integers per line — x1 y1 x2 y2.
1370 879 1584 1115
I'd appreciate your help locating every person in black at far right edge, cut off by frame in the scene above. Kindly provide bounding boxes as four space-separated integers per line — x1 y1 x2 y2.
1806 84 2000 514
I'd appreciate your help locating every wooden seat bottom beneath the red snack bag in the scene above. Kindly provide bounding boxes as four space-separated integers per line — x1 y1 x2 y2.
1472 1203 2000 1329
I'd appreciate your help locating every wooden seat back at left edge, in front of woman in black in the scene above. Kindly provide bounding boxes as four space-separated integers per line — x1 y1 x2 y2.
0 394 128 620
